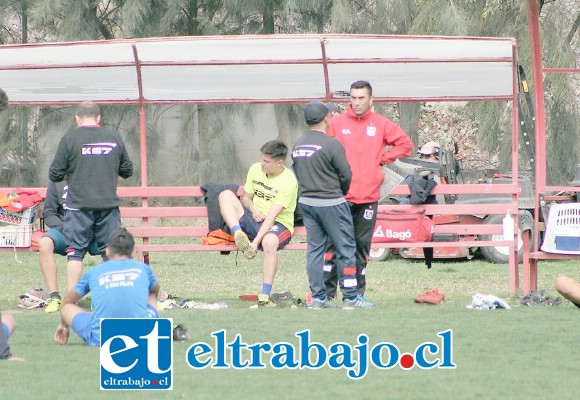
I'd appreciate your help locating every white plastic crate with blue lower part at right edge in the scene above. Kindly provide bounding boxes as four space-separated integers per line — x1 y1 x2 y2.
541 203 580 254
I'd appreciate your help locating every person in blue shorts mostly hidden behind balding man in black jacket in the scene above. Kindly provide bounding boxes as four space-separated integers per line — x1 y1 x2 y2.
38 181 99 313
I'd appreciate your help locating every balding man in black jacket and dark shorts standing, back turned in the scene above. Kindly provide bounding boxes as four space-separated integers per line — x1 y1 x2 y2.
48 101 133 289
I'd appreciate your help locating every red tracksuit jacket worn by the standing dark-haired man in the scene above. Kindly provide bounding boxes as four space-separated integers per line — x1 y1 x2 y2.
326 105 413 204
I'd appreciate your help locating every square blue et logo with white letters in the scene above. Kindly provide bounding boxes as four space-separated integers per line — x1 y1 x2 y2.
100 318 173 390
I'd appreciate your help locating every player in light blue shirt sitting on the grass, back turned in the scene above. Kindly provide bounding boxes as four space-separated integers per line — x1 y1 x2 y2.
54 228 159 346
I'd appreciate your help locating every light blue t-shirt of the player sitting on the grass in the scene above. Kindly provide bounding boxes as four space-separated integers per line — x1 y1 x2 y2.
75 259 157 343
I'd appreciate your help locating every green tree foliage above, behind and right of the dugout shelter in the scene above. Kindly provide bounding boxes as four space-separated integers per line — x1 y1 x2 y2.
0 0 580 183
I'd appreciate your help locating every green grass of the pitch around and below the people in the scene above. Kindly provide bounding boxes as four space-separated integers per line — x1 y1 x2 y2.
0 251 580 400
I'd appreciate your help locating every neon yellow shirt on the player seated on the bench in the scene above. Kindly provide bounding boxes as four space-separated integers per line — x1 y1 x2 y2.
244 163 298 233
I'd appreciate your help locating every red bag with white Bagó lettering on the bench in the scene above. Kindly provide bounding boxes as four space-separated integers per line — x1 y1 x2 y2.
372 210 433 243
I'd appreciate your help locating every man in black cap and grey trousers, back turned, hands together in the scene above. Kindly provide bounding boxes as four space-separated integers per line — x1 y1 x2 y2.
292 101 373 309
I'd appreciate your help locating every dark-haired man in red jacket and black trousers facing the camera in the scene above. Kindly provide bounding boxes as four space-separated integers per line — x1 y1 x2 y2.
324 81 413 298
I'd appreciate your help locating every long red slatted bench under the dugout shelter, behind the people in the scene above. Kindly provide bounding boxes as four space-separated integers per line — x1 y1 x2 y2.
0 184 519 294
